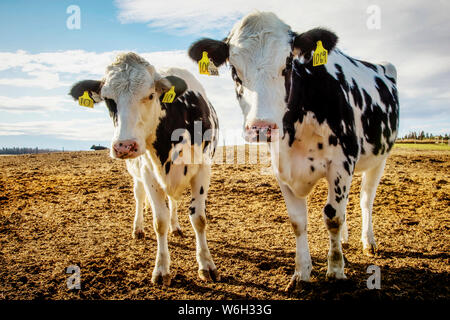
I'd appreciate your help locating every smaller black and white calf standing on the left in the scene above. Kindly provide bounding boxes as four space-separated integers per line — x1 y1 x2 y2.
70 53 219 285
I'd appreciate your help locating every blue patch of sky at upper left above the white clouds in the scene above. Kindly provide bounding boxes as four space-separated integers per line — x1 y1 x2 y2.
0 0 213 53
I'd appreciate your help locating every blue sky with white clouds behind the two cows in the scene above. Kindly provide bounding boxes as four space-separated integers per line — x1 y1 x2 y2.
0 0 450 150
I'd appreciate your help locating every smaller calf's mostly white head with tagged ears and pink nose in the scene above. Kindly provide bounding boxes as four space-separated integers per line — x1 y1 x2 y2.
70 53 186 159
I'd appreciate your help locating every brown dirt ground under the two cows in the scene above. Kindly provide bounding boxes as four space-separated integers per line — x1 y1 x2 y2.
0 145 450 300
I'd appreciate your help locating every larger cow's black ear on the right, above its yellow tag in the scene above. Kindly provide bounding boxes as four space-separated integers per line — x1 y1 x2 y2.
292 28 338 59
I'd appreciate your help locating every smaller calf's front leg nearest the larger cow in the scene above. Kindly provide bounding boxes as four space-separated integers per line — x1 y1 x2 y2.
189 165 220 281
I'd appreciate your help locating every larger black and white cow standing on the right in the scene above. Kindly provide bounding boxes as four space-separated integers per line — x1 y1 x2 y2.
189 12 399 288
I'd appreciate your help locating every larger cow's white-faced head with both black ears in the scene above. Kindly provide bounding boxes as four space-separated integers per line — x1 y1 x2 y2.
189 12 337 142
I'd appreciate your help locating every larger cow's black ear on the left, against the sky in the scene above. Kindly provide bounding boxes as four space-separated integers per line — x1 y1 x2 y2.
188 38 230 67
